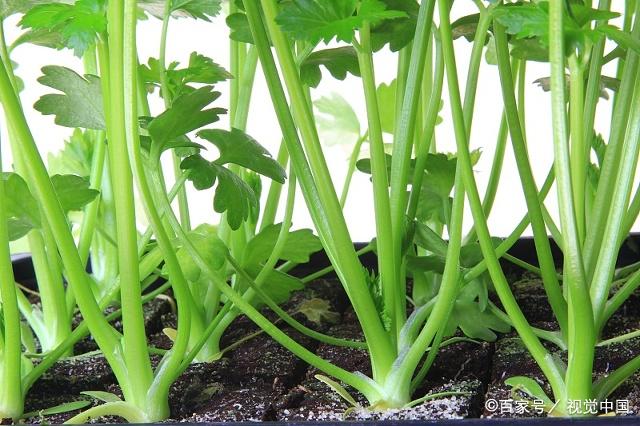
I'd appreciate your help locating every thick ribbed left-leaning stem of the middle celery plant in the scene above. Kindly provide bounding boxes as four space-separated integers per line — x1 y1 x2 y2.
250 0 394 377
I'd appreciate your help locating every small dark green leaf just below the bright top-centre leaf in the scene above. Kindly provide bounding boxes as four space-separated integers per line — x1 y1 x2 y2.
300 46 360 87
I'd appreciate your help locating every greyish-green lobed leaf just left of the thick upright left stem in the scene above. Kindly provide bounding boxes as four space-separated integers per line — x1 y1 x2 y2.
34 65 106 130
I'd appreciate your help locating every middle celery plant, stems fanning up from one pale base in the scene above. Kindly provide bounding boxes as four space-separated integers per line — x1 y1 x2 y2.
225 0 526 408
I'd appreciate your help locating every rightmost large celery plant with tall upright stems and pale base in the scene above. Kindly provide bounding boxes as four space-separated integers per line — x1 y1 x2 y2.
456 1 639 415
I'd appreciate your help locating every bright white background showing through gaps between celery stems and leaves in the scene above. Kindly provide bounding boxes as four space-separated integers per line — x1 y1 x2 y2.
2 1 628 241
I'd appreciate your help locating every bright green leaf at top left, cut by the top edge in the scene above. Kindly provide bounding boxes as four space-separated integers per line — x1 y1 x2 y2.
20 0 107 56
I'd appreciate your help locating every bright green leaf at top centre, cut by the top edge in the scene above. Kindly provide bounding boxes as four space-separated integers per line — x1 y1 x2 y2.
277 0 406 43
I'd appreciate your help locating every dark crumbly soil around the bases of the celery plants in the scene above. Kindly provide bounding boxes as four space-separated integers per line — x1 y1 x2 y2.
15 260 640 423
